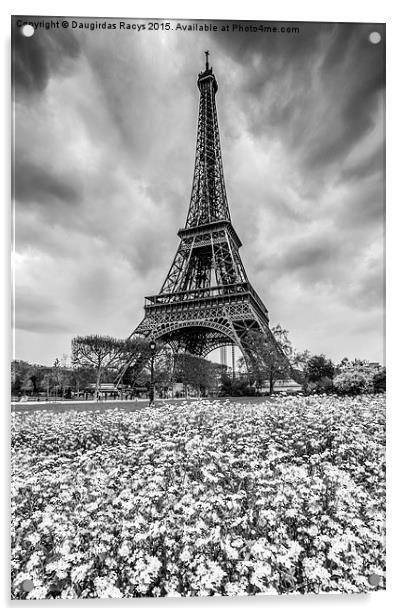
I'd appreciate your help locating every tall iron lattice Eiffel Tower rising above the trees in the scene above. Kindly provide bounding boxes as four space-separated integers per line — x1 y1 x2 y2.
125 52 286 362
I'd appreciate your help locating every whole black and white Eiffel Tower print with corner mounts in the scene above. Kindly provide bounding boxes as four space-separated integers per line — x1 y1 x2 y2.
10 14 386 605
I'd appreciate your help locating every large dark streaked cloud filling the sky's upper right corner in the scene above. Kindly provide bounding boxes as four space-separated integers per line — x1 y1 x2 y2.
212 23 385 173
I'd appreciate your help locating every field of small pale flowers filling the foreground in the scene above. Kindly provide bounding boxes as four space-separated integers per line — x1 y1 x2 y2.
12 395 385 599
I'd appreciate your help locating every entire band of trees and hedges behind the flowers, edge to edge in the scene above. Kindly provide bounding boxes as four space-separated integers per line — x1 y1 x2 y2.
11 324 386 397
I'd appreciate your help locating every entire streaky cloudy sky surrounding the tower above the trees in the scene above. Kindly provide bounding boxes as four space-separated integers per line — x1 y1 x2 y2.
13 18 385 364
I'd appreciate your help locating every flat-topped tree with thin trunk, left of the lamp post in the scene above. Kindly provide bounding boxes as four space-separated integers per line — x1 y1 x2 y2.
71 335 128 397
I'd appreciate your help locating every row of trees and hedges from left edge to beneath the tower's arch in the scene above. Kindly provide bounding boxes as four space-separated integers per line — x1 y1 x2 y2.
11 335 226 398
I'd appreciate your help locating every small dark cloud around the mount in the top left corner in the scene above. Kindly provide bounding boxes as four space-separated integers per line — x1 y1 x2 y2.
12 16 80 94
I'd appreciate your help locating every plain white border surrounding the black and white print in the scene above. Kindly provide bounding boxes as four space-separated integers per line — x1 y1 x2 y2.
0 0 402 616
